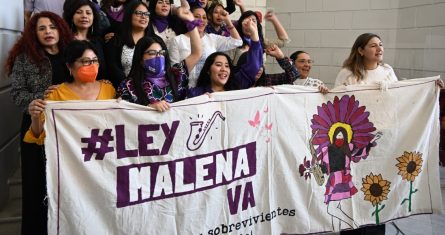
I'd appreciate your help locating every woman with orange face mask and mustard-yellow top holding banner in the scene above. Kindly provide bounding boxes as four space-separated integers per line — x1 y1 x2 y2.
24 40 115 145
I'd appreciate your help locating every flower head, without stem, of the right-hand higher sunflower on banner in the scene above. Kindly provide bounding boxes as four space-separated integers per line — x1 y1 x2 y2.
396 151 423 182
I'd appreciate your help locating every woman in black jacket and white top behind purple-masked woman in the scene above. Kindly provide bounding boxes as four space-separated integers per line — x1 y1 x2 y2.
105 1 150 87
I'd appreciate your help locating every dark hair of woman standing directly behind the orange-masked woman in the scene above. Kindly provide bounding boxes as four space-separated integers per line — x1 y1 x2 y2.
63 0 100 39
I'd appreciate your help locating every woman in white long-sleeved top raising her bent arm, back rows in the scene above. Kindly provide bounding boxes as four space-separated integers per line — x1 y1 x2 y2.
170 7 242 87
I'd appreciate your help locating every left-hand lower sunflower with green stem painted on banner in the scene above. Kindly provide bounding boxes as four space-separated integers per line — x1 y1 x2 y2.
361 172 391 224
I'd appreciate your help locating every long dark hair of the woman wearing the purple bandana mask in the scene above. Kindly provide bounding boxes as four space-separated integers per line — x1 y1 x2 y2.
128 36 178 105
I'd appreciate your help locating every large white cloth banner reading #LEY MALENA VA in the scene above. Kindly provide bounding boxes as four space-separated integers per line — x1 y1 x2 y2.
45 78 442 234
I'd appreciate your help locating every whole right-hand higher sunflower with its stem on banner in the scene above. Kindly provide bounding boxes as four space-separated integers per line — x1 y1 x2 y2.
396 151 423 212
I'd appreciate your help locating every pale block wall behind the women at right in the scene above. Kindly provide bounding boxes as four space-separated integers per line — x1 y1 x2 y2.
257 0 445 86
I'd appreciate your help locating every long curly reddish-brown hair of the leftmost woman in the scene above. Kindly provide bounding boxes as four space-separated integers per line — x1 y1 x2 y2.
5 11 73 76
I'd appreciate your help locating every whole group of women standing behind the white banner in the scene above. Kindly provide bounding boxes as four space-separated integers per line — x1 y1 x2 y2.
5 0 442 234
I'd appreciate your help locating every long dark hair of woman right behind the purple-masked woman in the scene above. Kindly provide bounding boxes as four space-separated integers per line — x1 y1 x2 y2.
119 1 150 48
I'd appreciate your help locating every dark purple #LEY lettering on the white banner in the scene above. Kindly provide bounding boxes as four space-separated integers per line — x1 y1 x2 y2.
80 121 179 162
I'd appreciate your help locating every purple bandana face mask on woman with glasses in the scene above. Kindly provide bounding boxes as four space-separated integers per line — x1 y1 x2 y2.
144 56 168 88
